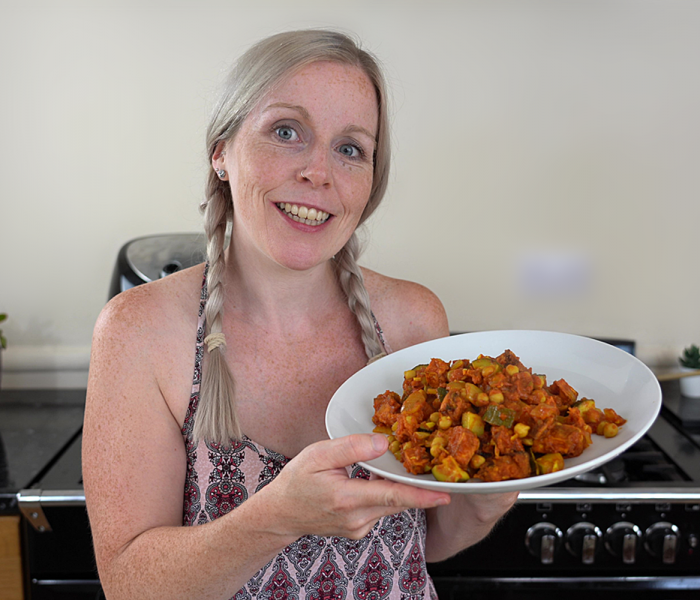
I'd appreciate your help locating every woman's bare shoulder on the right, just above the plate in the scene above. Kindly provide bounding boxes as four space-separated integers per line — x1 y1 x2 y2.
362 268 449 350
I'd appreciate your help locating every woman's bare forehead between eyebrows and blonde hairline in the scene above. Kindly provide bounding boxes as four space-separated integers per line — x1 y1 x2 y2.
253 61 379 135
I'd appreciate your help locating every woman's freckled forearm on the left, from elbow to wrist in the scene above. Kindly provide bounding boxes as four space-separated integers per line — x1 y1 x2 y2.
98 498 294 600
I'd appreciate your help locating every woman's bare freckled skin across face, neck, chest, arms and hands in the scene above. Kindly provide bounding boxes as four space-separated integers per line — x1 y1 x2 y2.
82 58 514 600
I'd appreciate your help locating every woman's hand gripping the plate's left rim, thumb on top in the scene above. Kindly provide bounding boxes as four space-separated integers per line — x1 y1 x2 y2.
261 434 450 539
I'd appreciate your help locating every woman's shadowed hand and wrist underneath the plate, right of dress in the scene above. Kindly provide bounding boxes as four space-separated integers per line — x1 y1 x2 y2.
425 494 517 562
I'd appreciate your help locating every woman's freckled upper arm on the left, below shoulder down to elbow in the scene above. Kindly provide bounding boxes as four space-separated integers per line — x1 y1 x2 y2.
82 290 186 564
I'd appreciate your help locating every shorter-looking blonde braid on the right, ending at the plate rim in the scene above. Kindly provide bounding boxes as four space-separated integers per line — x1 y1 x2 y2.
335 233 384 360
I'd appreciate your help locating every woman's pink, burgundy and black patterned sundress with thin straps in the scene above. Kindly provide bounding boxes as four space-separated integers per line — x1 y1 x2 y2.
182 269 437 600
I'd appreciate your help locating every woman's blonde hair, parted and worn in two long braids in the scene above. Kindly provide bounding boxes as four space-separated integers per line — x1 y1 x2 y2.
193 29 390 444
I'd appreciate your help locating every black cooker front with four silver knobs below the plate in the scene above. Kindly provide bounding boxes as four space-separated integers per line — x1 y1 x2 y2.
428 487 700 600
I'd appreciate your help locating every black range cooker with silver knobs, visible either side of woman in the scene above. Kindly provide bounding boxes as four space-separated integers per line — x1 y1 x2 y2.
8 381 700 600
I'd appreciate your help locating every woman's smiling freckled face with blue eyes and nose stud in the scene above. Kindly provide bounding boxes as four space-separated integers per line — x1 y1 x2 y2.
212 61 378 270
